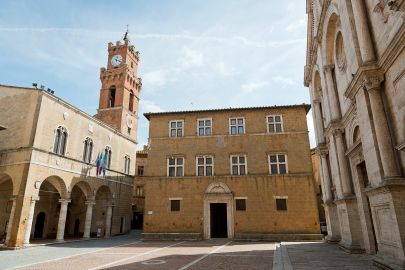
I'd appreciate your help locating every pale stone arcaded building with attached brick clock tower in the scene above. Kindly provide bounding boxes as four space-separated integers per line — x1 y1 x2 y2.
0 34 141 247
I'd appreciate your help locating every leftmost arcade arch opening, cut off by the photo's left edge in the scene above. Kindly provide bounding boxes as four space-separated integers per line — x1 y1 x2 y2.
0 174 14 242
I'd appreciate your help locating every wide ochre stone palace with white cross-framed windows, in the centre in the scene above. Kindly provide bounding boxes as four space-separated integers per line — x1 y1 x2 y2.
142 104 321 240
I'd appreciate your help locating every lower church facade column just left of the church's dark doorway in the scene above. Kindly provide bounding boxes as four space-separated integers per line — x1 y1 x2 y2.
334 129 353 196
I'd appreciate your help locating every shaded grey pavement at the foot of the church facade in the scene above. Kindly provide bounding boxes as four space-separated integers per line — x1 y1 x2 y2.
273 241 374 270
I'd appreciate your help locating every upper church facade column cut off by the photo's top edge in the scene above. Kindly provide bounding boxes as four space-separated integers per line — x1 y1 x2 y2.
350 0 375 63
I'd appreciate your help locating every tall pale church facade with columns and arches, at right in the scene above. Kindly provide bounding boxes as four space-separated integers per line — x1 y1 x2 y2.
304 0 405 269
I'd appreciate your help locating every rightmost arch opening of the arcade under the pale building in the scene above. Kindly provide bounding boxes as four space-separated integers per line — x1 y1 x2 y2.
91 186 112 236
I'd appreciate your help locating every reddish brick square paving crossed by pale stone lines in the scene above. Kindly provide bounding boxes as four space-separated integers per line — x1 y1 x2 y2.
0 231 275 270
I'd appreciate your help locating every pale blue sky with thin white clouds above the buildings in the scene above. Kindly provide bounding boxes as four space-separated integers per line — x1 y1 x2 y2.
0 0 314 148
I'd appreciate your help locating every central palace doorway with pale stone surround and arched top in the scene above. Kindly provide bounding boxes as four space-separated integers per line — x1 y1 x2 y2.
204 182 234 239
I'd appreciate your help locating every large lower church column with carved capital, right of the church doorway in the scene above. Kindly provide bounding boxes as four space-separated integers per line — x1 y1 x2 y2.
364 76 400 178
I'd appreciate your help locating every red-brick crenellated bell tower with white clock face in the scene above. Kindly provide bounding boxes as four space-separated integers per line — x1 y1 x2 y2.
96 32 142 140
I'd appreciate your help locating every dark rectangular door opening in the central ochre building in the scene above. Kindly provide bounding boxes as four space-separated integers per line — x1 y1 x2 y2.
210 203 228 238
